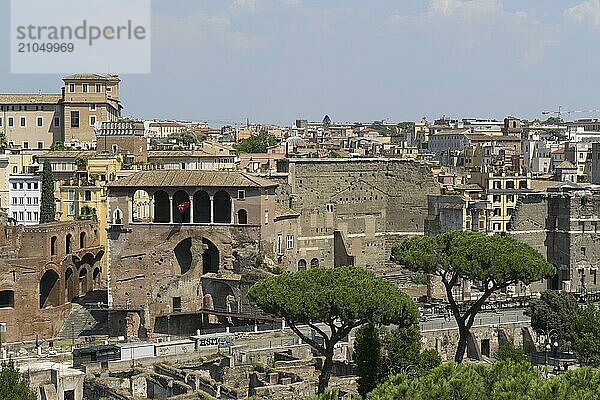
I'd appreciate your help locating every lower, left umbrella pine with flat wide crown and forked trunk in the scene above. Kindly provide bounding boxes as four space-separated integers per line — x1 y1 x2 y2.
248 267 417 393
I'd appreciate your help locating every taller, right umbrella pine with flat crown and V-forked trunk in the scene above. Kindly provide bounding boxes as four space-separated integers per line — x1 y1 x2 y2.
392 231 555 363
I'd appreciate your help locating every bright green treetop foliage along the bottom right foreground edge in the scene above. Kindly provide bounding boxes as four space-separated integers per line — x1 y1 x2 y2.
367 362 600 400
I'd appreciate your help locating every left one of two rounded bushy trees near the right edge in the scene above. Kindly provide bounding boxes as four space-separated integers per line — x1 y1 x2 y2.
525 290 579 341
